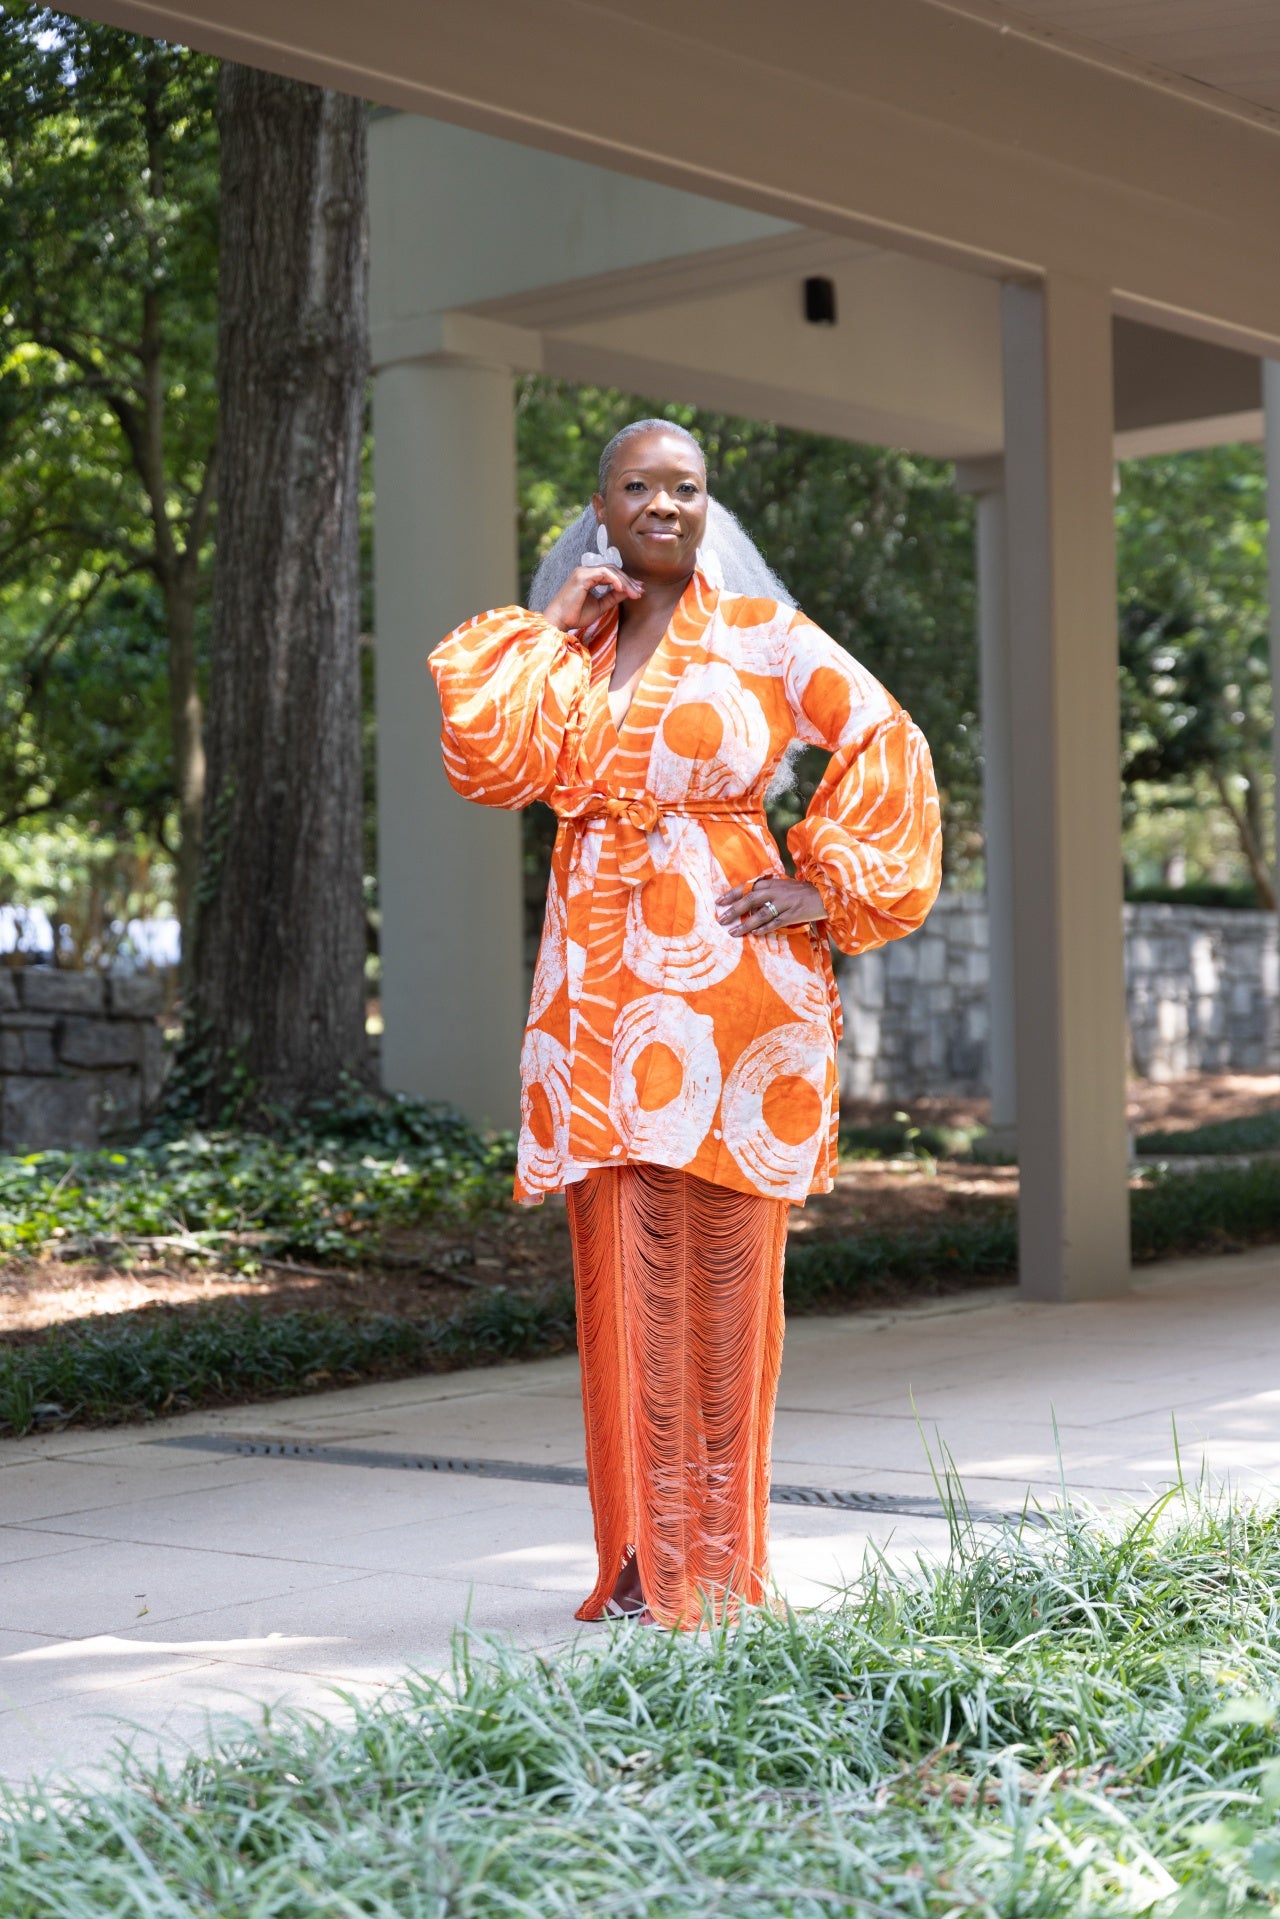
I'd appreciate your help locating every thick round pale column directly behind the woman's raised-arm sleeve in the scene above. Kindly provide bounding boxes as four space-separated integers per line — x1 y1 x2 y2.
374 361 526 1126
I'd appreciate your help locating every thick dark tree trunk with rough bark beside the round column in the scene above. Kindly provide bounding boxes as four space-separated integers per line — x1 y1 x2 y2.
188 65 368 1115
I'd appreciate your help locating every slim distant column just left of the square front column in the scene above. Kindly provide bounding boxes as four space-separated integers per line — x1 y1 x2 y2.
956 459 1017 1148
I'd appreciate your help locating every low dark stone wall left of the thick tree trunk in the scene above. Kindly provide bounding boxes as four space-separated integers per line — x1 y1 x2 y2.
0 965 165 1151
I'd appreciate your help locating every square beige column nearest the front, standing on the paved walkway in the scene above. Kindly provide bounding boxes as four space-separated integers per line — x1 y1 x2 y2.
1002 276 1128 1299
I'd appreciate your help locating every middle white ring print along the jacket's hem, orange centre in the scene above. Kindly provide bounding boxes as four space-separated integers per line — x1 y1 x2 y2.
608 992 720 1167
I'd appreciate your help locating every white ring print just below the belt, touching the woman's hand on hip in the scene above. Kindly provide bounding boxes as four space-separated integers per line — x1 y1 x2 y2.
622 816 743 992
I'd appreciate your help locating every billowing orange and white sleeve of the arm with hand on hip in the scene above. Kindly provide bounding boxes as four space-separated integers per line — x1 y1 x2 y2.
785 614 942 954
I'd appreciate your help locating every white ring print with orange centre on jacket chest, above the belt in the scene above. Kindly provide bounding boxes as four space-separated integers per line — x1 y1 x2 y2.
649 660 771 800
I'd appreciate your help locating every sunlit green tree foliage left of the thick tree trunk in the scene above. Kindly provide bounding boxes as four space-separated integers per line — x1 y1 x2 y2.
0 6 217 928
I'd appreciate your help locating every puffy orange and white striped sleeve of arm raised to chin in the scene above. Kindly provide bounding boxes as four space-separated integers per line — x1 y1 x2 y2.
428 606 591 808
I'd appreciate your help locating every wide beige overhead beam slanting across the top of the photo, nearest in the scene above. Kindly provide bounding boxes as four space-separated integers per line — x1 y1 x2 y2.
84 0 1280 351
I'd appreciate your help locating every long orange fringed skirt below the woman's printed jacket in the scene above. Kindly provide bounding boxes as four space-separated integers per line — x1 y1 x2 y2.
566 1165 789 1627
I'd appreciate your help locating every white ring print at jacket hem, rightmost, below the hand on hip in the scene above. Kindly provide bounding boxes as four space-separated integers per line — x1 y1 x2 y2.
722 1021 831 1197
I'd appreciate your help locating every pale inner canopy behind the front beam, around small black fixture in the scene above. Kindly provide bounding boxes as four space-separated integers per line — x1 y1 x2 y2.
370 113 1263 459
